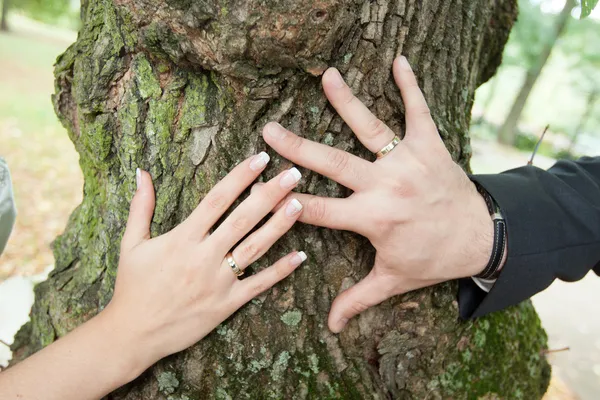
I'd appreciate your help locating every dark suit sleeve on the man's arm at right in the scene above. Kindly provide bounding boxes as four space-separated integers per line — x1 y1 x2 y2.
458 157 600 318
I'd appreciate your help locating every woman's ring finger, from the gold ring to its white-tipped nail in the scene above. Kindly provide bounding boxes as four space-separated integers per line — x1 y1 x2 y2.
227 198 302 270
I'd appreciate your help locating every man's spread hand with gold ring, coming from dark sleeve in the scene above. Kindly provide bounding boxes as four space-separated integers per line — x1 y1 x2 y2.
263 57 493 332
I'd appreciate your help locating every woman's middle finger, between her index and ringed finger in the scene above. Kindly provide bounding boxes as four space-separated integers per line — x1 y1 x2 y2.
207 168 302 253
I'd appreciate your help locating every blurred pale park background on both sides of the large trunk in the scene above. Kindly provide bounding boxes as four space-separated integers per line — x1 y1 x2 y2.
0 0 600 400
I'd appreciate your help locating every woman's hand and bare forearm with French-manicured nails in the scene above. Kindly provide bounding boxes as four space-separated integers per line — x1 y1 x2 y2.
0 153 306 400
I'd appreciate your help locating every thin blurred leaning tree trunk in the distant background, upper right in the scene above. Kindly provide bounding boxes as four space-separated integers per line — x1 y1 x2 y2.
498 0 577 146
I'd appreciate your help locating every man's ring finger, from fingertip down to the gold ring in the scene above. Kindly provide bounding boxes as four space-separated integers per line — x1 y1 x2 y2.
323 68 395 153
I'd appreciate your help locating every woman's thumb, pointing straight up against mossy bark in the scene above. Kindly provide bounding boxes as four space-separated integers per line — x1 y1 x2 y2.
121 168 155 250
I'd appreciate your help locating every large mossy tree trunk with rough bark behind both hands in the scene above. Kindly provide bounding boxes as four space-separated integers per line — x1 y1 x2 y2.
13 0 549 399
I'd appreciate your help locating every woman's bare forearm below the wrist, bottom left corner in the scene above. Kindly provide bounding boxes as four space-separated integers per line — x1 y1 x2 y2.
0 310 147 400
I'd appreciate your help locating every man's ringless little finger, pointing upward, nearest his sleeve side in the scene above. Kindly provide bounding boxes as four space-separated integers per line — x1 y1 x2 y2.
393 56 439 139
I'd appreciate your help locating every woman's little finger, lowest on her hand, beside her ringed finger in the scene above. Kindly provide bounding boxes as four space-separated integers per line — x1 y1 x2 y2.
232 251 306 309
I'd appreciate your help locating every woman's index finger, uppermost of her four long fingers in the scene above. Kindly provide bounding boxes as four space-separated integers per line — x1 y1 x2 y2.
183 151 269 240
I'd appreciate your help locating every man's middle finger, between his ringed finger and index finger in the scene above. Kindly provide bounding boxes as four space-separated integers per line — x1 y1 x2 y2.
263 122 372 191
